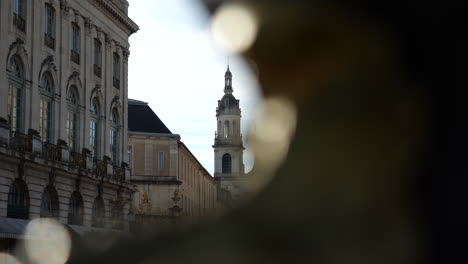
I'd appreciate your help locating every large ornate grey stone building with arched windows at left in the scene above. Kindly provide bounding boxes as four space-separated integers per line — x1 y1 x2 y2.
0 0 138 250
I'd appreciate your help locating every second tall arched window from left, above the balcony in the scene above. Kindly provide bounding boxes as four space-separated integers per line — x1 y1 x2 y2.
39 71 55 141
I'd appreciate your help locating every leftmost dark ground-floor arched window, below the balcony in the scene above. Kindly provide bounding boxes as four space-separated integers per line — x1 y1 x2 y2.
7 179 29 219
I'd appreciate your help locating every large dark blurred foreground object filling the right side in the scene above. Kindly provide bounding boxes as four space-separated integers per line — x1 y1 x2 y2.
72 0 468 263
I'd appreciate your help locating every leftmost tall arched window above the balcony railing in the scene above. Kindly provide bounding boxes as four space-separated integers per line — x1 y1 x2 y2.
7 55 24 131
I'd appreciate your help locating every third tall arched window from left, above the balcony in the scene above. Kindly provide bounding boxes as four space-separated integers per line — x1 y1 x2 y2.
66 85 79 151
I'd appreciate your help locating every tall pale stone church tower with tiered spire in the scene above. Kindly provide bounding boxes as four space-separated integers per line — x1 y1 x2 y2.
213 65 245 198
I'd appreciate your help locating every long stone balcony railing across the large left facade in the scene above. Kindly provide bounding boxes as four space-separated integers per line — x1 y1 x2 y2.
0 123 130 182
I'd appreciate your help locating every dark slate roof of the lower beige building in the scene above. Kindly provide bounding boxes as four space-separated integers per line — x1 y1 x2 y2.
128 99 172 134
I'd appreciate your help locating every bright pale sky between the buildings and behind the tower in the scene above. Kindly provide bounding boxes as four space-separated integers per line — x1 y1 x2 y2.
128 0 260 174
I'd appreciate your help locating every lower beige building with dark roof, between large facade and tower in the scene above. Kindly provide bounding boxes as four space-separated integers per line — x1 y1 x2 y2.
128 99 217 227
